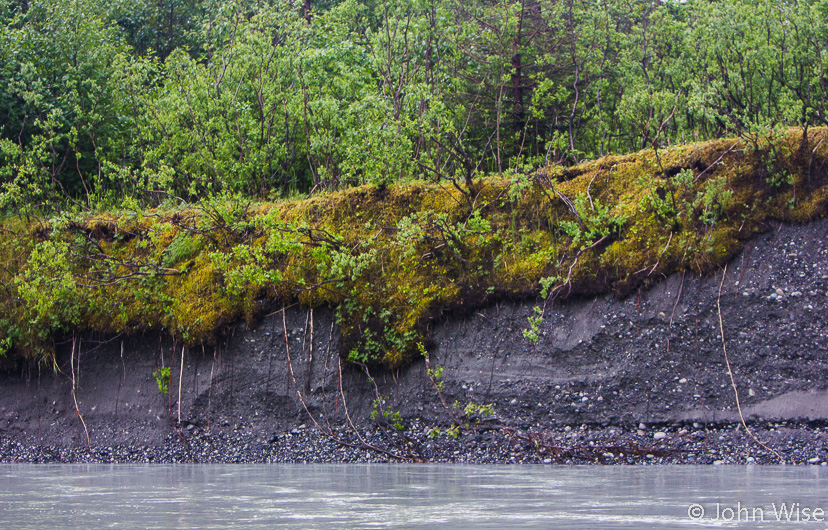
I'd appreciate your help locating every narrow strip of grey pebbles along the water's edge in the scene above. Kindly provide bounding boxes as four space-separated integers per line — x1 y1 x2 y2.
0 421 828 466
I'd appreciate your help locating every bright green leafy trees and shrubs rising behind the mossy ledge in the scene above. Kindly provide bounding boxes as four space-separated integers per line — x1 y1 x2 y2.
0 0 828 211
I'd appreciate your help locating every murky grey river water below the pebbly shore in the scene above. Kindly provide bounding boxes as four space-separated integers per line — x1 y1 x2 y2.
0 465 828 530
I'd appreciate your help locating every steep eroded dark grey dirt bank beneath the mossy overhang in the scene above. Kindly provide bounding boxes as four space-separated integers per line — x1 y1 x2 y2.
0 216 828 461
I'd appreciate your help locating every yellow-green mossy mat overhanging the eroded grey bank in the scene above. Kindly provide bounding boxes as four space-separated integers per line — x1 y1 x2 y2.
0 129 828 366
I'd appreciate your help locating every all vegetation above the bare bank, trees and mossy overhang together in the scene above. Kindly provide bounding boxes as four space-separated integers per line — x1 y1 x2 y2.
0 0 828 365
